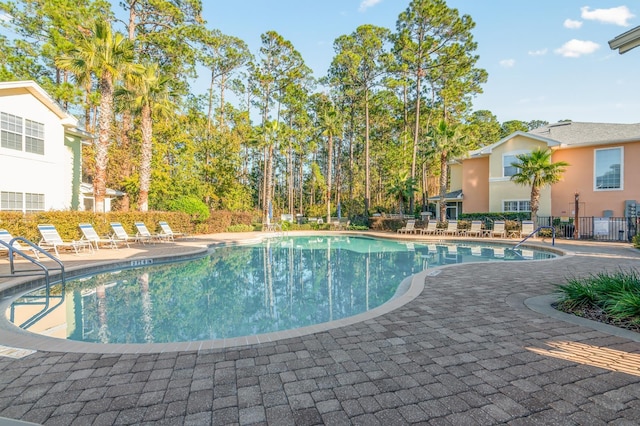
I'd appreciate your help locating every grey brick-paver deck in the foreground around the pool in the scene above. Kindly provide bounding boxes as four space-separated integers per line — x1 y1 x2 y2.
0 237 640 426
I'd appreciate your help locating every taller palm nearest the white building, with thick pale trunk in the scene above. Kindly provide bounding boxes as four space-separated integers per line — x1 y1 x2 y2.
56 20 139 212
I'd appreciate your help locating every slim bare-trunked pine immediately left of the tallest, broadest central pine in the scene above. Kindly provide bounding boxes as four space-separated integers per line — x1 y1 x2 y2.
329 25 391 215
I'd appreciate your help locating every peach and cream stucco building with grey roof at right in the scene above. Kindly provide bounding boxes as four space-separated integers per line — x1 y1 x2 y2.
448 122 640 217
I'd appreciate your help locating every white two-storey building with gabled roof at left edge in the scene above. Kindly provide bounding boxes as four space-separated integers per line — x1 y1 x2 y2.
0 81 90 212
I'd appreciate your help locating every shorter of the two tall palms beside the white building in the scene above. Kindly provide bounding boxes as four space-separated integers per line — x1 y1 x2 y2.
116 64 174 212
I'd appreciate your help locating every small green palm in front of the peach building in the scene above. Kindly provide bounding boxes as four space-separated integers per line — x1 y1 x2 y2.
511 148 569 227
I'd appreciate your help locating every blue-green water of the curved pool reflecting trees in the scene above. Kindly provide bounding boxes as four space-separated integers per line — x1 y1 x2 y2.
9 236 554 343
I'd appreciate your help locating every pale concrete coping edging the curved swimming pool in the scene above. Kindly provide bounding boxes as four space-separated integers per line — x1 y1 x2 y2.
0 232 571 354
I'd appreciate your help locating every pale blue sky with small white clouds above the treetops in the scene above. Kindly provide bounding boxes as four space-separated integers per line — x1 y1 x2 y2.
198 0 640 123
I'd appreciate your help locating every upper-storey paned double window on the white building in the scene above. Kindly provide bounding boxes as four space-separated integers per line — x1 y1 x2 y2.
0 112 44 155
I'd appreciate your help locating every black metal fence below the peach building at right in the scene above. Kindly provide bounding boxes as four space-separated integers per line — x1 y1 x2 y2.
538 216 640 241
